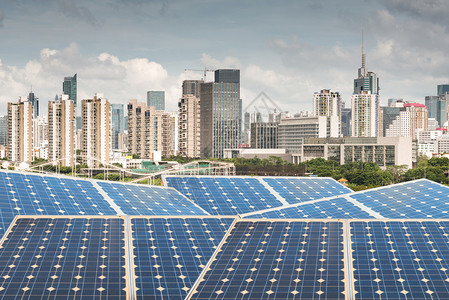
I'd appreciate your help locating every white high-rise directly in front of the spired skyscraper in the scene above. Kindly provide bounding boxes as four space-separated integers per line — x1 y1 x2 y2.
351 91 379 137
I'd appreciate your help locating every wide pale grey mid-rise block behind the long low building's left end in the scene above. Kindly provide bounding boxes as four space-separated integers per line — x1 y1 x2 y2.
278 117 327 153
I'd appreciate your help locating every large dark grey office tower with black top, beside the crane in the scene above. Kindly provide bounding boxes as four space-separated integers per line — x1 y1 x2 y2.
200 70 241 158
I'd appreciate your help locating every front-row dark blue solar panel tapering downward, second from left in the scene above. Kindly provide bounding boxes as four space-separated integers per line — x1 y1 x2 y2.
131 217 234 299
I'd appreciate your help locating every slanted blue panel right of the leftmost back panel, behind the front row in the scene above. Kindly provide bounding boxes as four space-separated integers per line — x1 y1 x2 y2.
98 181 207 215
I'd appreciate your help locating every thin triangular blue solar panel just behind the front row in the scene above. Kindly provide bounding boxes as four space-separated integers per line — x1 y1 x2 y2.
243 197 374 219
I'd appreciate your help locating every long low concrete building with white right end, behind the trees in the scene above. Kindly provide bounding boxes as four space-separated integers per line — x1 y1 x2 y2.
292 137 413 168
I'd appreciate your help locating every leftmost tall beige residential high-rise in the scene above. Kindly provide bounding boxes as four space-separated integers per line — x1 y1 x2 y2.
8 99 33 162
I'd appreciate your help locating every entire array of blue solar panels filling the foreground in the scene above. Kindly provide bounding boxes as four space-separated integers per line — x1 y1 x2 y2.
0 172 449 299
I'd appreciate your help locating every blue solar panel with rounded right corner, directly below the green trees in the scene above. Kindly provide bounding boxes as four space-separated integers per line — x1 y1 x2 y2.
261 177 352 204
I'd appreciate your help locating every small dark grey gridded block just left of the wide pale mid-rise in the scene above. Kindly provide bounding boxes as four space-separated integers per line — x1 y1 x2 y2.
250 122 279 149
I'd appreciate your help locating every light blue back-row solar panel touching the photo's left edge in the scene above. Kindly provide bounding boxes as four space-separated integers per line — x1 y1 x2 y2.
0 172 117 235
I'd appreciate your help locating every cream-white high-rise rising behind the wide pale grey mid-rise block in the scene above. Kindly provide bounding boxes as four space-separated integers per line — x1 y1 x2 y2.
313 89 341 137
